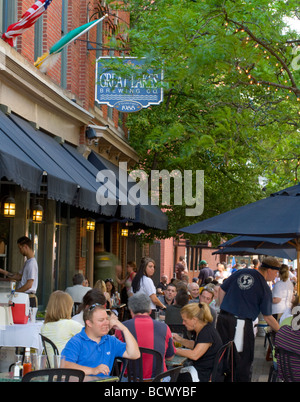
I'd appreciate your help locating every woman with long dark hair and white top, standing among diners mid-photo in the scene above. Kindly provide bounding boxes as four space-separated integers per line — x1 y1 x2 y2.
132 257 166 318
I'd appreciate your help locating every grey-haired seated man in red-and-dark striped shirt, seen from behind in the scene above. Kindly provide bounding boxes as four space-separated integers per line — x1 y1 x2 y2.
115 292 175 379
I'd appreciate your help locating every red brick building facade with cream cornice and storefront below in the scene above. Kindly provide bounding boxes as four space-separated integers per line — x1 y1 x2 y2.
0 0 138 305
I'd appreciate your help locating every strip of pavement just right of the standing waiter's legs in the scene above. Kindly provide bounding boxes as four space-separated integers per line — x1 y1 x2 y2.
251 336 272 382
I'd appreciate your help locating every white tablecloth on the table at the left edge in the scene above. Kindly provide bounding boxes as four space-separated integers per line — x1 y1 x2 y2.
0 321 43 352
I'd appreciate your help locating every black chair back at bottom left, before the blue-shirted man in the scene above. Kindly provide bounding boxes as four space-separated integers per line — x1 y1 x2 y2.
22 368 85 382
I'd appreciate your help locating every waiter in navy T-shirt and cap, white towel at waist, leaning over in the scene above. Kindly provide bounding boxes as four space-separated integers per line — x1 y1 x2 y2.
217 257 281 382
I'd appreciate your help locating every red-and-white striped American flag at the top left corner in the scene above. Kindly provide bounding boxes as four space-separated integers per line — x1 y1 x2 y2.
2 0 52 46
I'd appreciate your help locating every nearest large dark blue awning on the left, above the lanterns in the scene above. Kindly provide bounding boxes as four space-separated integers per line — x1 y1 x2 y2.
0 112 118 216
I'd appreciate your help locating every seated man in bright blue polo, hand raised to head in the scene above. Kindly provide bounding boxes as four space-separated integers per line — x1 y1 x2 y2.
62 304 140 376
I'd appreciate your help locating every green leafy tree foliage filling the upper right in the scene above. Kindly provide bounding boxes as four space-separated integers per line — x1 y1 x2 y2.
101 0 300 237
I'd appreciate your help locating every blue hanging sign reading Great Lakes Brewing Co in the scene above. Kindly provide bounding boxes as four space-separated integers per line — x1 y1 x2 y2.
95 56 163 113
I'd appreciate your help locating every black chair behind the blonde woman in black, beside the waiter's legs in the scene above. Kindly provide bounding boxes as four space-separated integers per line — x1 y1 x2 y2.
210 341 235 382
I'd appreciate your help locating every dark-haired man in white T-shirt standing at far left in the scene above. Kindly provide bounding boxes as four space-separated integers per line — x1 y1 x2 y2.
0 236 38 307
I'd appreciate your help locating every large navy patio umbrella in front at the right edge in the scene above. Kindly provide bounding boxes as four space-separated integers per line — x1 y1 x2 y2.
178 184 300 292
